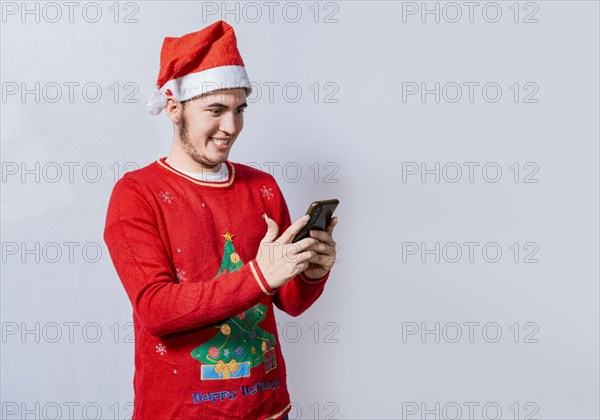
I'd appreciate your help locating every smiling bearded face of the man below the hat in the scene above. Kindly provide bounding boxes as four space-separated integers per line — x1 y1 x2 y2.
178 88 247 172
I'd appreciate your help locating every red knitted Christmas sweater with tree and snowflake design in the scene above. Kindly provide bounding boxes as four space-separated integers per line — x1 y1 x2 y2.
104 157 329 420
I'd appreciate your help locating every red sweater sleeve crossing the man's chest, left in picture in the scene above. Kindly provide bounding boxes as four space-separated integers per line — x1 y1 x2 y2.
104 176 275 336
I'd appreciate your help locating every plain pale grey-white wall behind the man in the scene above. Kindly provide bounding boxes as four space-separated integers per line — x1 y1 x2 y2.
0 1 600 419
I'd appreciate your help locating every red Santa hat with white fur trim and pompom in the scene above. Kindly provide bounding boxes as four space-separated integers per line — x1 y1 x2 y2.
146 20 252 115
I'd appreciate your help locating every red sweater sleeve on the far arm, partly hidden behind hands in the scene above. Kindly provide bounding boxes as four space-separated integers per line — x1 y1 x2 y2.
272 178 331 316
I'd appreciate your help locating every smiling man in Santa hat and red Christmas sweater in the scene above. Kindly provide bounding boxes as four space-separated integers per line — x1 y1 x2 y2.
104 21 337 420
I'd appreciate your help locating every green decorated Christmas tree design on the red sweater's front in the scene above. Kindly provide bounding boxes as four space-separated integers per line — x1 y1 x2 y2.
191 232 277 380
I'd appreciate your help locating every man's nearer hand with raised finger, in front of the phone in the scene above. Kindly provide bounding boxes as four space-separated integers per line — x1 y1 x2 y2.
256 214 319 289
